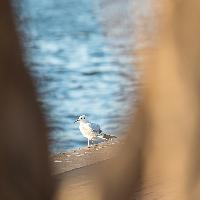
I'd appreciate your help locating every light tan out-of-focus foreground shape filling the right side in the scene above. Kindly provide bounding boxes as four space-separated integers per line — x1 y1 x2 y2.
57 0 200 200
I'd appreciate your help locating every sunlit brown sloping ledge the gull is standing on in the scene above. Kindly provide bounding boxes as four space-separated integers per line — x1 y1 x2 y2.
51 139 123 175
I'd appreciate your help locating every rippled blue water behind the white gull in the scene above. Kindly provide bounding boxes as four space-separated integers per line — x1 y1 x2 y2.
16 0 141 152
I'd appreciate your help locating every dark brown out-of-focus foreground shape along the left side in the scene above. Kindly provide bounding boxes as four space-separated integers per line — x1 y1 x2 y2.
0 0 52 200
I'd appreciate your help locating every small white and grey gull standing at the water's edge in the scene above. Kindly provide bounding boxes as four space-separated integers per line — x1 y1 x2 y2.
74 115 116 147
